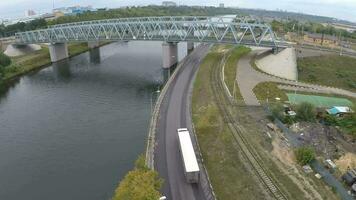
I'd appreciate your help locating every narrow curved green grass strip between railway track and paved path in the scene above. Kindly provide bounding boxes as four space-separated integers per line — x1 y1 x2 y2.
224 46 251 94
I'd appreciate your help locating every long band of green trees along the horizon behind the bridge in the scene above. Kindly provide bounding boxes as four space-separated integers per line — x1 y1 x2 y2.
0 6 356 39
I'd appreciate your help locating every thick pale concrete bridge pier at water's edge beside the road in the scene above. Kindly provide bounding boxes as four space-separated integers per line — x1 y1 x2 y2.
162 42 178 68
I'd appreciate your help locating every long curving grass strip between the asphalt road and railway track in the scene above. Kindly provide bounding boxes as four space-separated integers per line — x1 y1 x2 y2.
192 46 264 199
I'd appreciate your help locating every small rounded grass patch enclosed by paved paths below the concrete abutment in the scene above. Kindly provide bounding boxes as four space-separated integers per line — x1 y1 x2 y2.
253 82 288 103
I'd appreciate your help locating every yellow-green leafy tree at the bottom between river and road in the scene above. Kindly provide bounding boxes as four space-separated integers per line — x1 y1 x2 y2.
112 156 162 200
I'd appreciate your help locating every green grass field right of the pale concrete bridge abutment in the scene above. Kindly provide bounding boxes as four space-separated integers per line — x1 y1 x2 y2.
298 55 356 92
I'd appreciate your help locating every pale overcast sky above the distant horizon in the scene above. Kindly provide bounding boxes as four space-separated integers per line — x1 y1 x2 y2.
0 0 356 22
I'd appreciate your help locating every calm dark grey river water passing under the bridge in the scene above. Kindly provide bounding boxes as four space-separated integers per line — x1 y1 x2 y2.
0 42 186 200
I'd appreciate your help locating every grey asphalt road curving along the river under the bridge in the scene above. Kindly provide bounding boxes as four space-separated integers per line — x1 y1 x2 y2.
154 45 209 200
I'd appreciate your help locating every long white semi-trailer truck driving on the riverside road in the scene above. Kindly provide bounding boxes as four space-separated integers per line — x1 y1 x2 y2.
177 128 200 183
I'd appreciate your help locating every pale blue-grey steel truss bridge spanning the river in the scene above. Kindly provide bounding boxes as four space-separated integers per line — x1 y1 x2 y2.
15 16 285 47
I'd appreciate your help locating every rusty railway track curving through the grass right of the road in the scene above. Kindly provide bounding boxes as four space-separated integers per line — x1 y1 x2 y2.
210 50 287 200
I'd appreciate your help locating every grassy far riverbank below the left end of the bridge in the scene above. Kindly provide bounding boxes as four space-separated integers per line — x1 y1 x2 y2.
3 43 105 83
